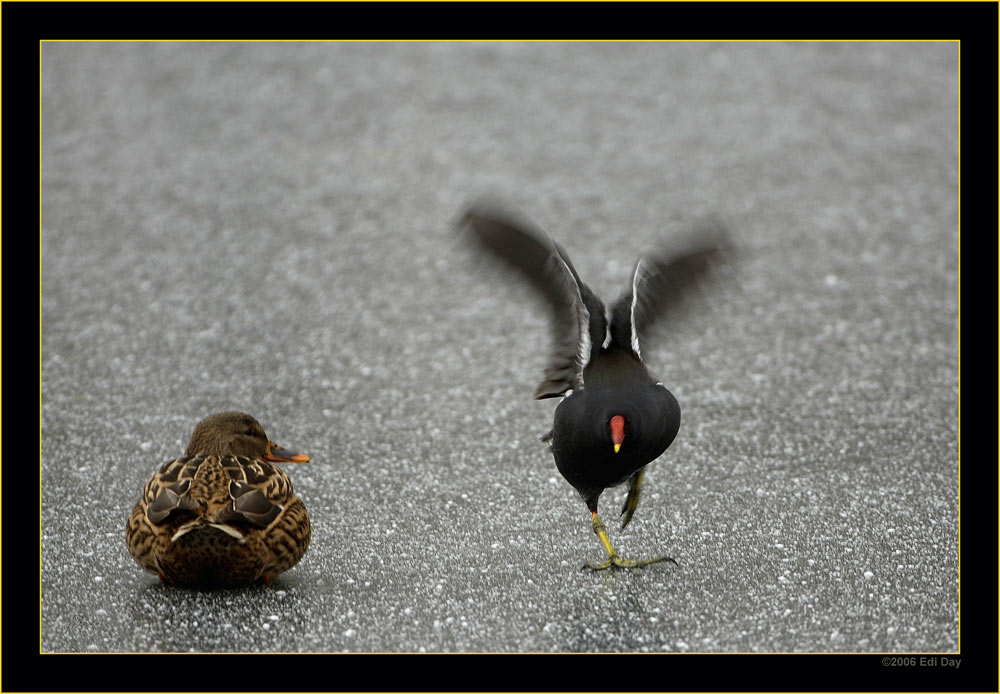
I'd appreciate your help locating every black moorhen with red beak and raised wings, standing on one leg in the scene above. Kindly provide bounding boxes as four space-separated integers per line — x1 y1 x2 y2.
458 203 724 570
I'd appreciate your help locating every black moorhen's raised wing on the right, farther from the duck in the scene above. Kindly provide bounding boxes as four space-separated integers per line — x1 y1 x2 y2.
610 222 730 357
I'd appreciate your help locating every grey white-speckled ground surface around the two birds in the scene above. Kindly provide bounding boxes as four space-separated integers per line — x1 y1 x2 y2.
40 43 959 653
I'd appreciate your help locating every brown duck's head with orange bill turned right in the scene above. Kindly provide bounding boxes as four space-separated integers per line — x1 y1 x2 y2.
185 412 309 463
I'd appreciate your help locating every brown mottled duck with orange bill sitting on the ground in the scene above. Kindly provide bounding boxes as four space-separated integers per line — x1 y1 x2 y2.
125 412 312 588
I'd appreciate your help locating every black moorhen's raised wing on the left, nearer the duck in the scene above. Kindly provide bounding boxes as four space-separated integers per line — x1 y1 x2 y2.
458 203 607 399
